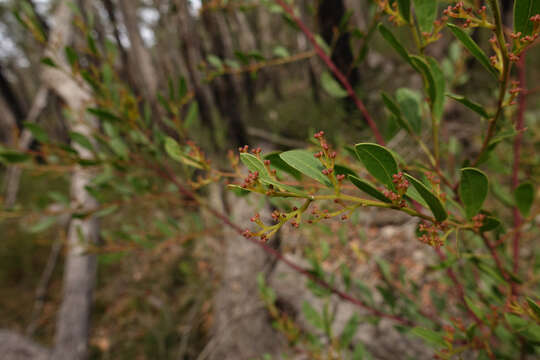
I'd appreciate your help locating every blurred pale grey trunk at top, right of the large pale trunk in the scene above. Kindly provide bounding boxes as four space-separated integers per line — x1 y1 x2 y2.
119 0 158 103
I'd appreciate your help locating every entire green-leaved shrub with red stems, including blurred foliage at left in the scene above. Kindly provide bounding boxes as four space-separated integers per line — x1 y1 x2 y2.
0 0 540 359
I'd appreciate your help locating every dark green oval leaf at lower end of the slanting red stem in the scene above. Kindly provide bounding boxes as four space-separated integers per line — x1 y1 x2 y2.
354 143 398 190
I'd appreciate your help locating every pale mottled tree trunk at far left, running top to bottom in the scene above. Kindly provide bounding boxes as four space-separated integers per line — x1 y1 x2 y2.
43 0 99 360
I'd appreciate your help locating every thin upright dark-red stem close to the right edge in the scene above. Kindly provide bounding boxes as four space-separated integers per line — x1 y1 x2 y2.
512 52 527 295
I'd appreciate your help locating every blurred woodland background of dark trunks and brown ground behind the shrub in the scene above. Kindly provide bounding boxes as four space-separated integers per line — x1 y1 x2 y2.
0 0 540 359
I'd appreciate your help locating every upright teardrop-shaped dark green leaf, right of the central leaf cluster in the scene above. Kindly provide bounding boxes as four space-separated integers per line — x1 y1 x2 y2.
459 168 489 219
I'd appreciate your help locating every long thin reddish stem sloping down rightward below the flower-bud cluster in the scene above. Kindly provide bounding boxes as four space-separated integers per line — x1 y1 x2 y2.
154 164 415 327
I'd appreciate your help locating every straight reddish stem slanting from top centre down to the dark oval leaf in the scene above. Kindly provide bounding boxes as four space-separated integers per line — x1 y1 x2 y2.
276 0 384 145
